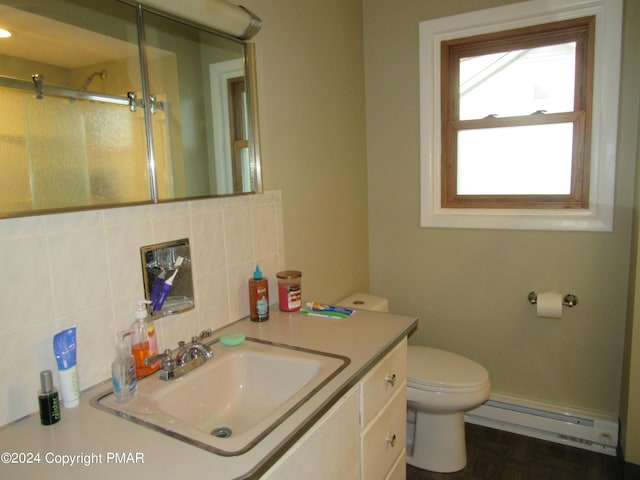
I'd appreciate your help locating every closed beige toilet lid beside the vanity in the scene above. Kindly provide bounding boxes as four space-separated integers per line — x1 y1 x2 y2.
407 345 489 389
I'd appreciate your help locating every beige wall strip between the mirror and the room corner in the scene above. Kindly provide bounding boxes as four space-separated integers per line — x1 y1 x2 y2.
243 0 369 302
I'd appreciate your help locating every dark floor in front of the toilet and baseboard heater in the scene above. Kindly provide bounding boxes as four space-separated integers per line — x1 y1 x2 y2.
407 424 621 480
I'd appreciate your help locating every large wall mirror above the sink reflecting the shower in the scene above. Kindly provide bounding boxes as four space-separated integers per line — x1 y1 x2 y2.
0 0 261 217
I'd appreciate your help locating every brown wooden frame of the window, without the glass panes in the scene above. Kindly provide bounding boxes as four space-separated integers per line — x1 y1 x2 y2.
440 16 595 209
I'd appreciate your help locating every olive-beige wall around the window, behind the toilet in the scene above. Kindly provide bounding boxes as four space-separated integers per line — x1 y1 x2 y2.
364 0 639 416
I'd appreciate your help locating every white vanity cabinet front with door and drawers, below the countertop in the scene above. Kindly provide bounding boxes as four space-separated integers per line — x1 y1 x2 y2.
261 338 407 480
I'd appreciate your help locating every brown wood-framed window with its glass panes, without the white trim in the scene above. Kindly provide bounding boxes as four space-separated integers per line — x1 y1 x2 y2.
441 17 595 208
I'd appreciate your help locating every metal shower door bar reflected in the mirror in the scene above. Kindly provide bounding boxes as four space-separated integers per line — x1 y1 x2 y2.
0 74 164 112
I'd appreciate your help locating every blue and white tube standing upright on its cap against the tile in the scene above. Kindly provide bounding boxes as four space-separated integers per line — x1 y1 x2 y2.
53 325 80 408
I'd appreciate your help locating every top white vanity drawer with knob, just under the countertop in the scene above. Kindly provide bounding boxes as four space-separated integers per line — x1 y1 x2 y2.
360 338 407 428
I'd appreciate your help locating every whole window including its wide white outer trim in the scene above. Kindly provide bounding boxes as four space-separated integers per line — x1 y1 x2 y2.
420 0 622 231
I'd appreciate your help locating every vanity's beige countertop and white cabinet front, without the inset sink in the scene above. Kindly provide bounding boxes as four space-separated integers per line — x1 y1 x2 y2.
0 309 418 480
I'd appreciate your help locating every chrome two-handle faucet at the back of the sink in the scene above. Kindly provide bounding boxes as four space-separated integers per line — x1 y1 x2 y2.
144 329 213 380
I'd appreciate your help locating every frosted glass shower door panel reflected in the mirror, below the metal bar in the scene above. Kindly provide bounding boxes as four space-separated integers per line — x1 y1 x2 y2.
0 89 151 213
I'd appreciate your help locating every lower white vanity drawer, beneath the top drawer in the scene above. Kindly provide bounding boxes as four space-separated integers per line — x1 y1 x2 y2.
362 382 407 480
